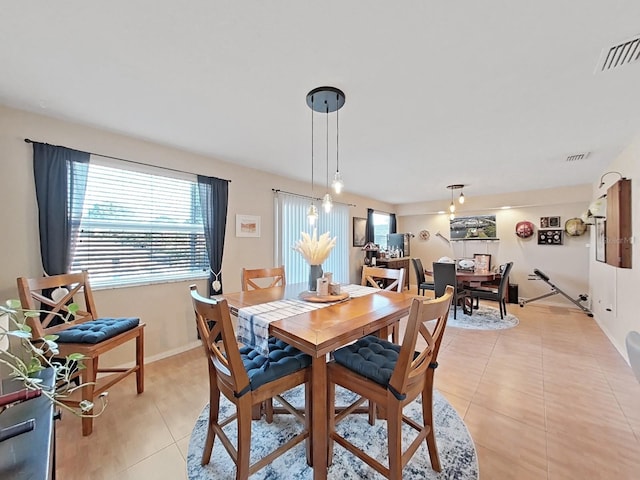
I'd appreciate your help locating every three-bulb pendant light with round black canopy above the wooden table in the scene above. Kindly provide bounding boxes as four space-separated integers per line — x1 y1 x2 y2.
307 87 345 222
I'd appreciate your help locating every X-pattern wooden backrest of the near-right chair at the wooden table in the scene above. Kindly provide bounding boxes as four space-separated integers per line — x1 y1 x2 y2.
389 286 454 394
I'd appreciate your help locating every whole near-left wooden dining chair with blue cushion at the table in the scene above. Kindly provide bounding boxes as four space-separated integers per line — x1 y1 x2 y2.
190 285 311 480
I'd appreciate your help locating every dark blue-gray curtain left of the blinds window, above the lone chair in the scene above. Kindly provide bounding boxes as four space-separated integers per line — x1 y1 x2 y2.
33 142 90 275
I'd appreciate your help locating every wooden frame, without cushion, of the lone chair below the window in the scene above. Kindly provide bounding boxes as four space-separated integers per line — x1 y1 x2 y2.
17 271 145 436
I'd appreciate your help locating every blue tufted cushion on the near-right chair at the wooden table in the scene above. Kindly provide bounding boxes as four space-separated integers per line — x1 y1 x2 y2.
333 335 406 400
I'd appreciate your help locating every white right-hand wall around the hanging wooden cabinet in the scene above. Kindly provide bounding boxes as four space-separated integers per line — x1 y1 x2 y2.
589 132 640 358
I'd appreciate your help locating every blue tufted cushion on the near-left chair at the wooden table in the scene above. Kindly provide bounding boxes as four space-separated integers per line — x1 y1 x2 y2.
240 337 311 394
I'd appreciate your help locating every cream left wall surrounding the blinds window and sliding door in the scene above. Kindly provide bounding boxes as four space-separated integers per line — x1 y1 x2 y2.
0 107 393 365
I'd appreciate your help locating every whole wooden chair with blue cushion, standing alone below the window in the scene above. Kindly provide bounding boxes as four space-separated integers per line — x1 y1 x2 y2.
17 271 145 436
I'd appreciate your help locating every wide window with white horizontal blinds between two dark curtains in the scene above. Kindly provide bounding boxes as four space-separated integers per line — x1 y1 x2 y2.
70 158 209 286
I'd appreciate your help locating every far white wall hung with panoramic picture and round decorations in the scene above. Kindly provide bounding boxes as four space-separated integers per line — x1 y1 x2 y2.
397 185 591 306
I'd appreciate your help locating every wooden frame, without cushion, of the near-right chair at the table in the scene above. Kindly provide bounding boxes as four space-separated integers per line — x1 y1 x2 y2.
327 286 453 480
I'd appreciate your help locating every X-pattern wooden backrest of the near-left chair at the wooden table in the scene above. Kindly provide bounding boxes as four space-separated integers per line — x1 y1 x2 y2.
190 285 249 393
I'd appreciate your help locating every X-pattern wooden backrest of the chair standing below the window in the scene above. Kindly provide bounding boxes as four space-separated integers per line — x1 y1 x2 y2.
17 271 98 338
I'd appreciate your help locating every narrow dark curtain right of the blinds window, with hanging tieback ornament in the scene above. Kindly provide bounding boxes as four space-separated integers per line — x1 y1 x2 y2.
198 175 229 296
